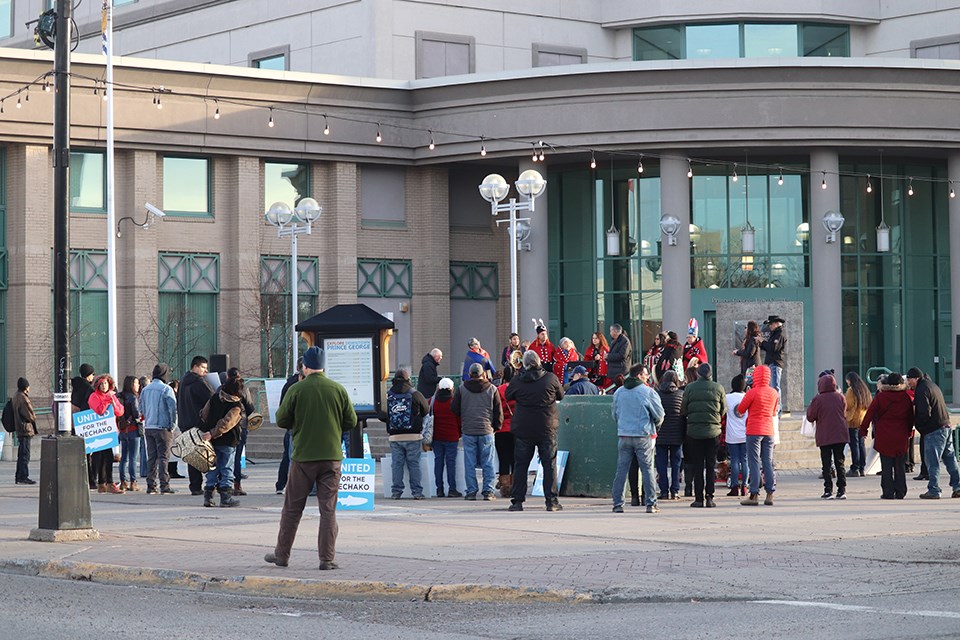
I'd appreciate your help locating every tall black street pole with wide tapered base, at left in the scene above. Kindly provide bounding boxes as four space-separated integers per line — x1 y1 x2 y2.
30 0 98 542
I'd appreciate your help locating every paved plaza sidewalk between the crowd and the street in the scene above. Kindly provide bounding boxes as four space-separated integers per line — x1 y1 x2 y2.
0 462 960 602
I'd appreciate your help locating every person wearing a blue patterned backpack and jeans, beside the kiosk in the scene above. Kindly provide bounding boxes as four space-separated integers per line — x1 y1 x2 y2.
384 366 430 500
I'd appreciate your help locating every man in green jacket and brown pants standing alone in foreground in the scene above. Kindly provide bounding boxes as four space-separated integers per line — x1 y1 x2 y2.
263 347 357 571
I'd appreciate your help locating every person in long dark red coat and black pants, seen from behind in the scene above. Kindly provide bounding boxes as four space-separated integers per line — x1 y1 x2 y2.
864 372 913 500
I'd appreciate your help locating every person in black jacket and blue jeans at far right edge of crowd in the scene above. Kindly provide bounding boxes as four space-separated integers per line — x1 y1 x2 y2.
906 367 960 500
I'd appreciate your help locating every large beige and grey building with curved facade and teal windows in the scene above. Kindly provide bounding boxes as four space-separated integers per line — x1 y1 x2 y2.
0 0 960 405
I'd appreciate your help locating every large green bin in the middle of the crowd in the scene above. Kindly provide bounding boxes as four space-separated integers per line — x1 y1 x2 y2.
557 396 617 498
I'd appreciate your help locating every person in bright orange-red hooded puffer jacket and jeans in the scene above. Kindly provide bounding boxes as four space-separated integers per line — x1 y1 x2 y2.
735 365 780 506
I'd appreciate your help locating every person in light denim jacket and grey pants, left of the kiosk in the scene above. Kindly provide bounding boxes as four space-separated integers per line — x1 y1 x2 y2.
140 362 177 495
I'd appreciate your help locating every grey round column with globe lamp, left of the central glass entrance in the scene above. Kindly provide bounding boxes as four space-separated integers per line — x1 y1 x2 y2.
660 154 691 332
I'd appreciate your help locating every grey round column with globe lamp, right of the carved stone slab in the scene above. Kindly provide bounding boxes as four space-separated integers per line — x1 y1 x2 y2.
808 150 853 375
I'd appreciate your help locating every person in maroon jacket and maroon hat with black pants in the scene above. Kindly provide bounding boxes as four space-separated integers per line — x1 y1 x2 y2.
807 373 850 500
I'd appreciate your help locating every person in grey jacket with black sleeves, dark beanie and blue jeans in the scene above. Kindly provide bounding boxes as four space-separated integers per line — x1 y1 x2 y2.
450 362 503 501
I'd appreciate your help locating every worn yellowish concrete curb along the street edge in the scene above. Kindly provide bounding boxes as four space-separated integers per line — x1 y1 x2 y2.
0 560 601 604
